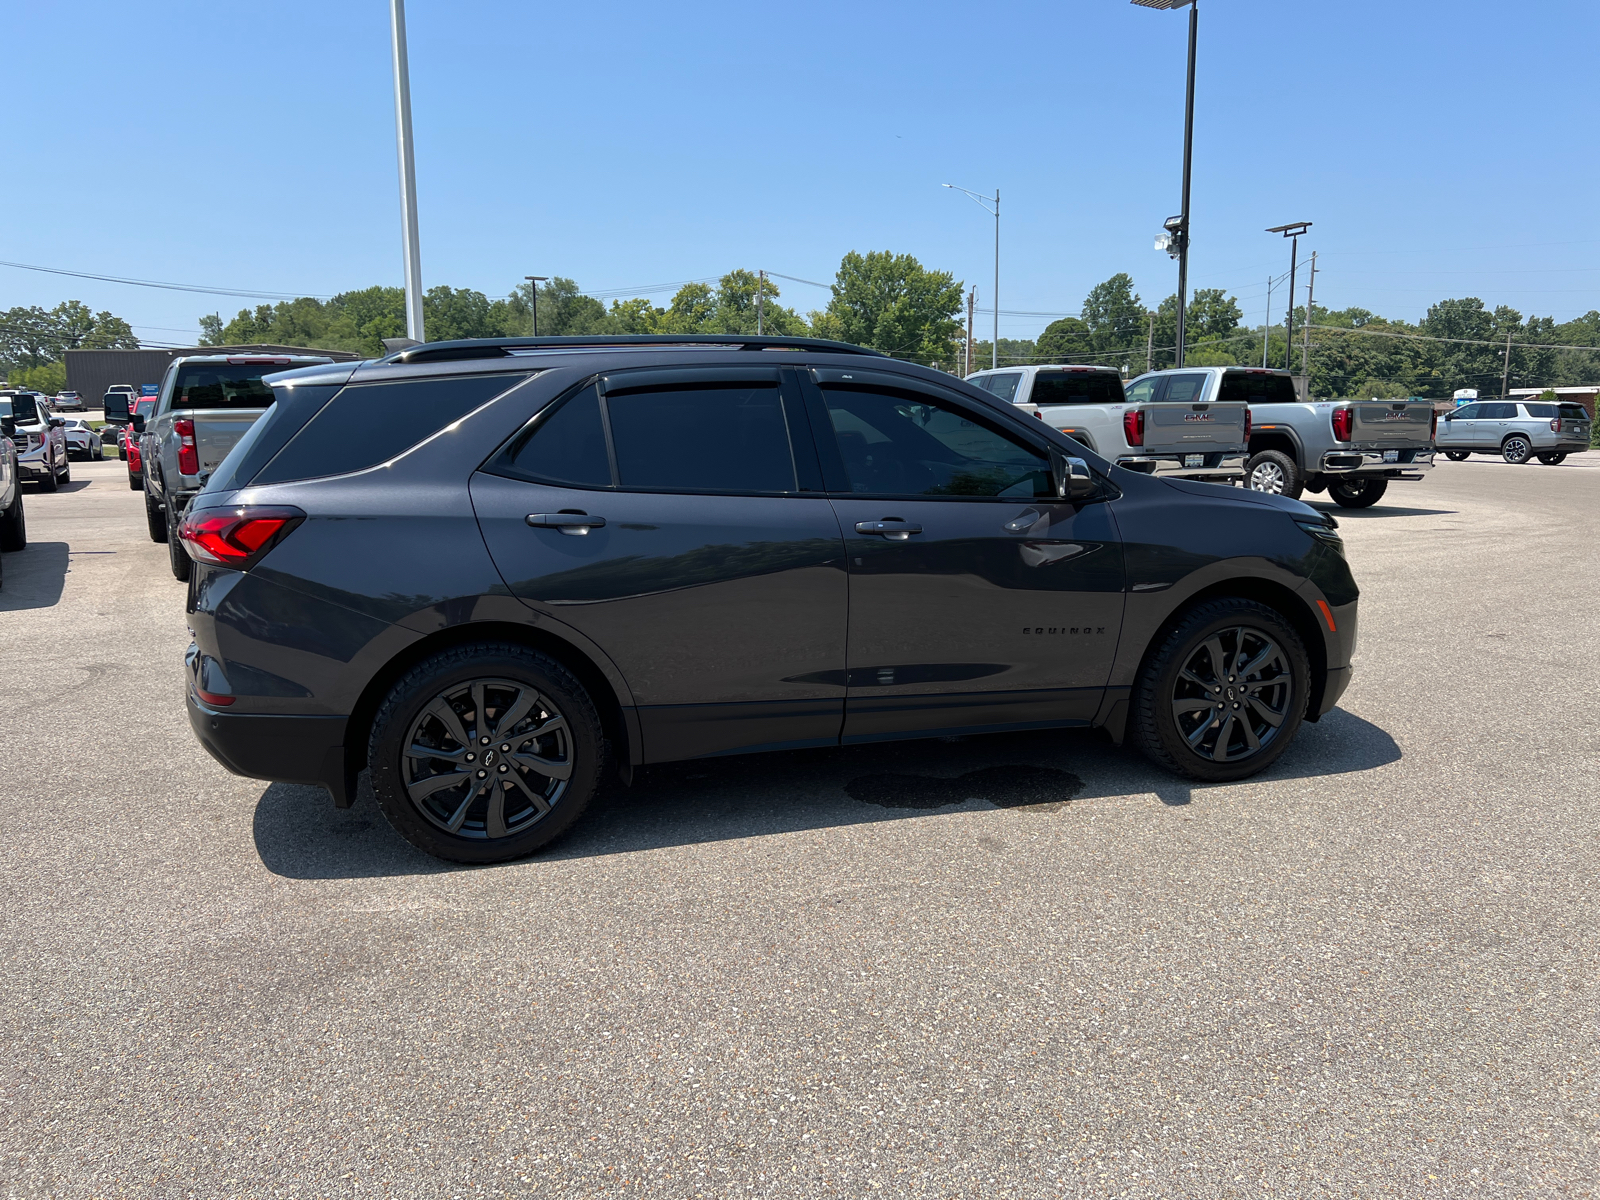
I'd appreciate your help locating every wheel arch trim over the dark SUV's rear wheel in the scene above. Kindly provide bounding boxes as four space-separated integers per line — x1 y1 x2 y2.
344 621 642 795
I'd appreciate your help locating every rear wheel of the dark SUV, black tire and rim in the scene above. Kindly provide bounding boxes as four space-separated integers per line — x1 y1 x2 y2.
366 642 608 862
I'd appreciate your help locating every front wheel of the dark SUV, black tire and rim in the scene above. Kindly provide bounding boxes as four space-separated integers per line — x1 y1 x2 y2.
1130 597 1310 782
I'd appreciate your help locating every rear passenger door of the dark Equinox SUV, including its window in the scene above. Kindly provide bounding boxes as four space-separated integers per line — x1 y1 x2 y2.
472 366 846 762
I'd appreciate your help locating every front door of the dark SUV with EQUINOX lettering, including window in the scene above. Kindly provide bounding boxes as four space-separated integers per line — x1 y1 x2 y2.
805 370 1123 742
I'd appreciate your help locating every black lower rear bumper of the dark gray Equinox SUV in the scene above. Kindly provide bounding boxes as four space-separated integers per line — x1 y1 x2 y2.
186 691 355 808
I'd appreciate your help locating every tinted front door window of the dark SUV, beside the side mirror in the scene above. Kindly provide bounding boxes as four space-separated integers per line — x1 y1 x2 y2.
824 386 1054 498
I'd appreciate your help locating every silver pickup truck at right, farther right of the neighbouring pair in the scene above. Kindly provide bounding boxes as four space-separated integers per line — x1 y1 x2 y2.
1128 366 1435 509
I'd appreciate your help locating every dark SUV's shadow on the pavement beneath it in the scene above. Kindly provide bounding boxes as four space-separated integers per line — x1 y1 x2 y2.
254 709 1400 878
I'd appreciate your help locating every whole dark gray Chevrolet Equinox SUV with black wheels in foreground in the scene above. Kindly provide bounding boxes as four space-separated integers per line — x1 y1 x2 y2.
178 334 1358 862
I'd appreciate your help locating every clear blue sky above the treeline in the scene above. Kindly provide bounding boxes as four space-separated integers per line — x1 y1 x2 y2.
0 0 1600 342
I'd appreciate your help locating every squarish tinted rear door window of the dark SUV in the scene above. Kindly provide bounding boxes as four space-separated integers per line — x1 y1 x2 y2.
605 382 797 494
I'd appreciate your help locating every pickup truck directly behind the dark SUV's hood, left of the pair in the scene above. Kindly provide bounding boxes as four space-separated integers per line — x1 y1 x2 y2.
966 366 1250 483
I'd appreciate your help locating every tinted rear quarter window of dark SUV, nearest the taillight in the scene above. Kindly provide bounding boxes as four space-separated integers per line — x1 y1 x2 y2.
253 374 525 483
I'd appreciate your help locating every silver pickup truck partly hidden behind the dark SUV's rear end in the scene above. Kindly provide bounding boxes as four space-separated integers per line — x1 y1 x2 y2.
133 354 334 579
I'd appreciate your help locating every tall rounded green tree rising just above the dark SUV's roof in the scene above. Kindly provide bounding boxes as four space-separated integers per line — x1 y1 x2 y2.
811 250 962 362
